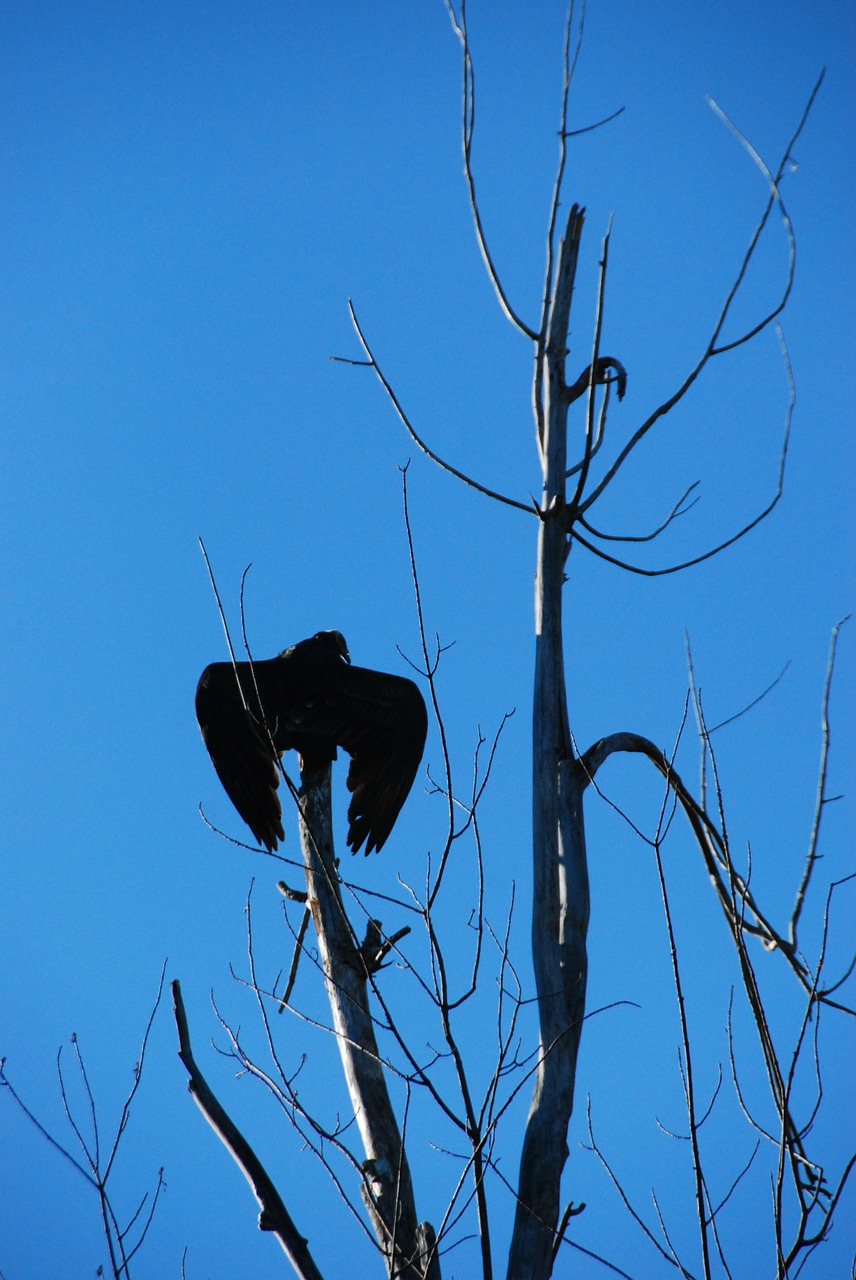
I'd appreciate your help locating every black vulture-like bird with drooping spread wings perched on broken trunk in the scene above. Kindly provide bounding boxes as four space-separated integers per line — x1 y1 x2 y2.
196 631 427 854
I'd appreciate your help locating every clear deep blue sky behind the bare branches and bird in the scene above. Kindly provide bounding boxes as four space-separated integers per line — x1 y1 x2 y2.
0 0 856 1280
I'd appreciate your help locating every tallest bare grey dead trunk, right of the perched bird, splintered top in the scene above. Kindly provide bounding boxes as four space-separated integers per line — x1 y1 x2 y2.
508 206 589 1280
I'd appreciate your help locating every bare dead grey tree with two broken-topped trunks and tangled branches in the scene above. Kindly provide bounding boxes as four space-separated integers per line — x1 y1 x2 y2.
170 3 853 1280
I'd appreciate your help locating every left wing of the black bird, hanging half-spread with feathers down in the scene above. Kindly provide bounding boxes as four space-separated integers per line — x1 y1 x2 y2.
196 662 283 850
